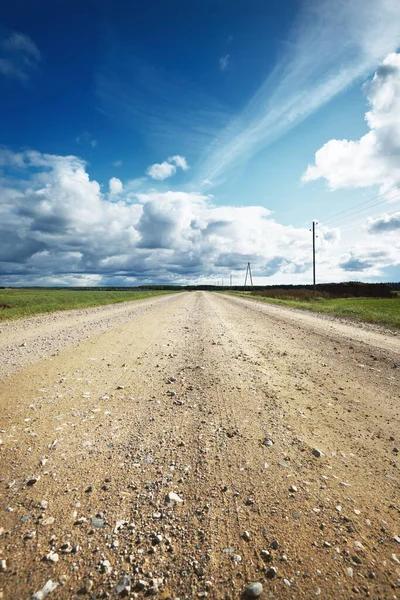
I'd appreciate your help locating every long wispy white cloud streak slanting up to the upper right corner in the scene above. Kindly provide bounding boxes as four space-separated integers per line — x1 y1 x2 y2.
199 0 400 182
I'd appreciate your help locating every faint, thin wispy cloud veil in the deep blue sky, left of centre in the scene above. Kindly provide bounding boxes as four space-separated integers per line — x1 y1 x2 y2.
96 53 232 158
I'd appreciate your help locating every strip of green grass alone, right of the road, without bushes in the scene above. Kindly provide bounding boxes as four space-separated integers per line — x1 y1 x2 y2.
223 292 400 328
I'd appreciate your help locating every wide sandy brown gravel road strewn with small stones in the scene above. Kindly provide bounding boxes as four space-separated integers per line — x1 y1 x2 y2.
0 292 400 600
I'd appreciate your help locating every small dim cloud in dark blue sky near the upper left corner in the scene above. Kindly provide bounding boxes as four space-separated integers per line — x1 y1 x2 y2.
0 32 41 83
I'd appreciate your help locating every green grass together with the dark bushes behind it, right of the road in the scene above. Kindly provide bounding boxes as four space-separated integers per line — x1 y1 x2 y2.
225 288 400 329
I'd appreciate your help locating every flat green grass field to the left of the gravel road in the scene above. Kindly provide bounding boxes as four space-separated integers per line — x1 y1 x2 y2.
0 289 178 321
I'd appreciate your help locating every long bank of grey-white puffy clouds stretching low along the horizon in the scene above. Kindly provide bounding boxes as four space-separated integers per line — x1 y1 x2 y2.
0 149 400 285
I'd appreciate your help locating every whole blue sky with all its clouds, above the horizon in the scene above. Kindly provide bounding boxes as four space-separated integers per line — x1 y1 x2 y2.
0 0 400 285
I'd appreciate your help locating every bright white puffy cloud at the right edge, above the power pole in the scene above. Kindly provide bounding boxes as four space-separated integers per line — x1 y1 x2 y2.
302 53 400 191
